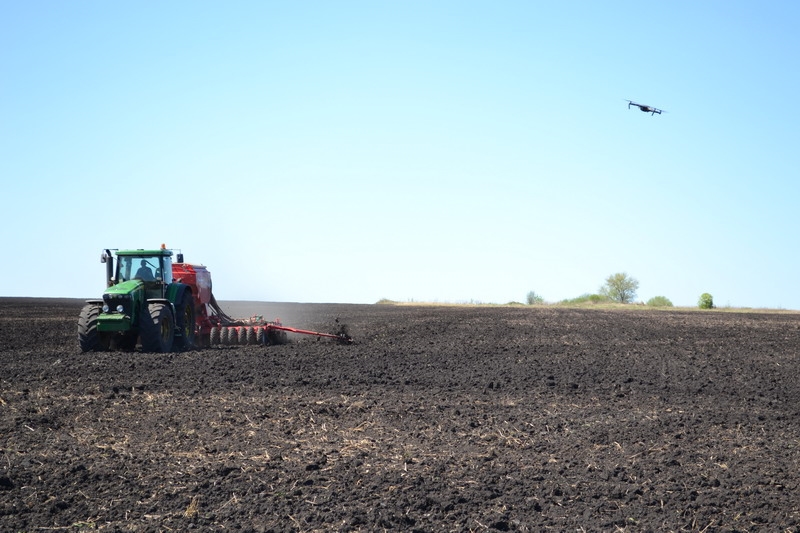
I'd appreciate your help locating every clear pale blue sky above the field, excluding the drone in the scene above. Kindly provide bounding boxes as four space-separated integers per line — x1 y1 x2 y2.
0 0 800 309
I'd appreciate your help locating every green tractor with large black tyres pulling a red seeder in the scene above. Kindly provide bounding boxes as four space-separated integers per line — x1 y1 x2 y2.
78 245 196 352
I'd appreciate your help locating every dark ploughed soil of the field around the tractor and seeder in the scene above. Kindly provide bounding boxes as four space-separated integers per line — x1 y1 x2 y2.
0 298 800 533
